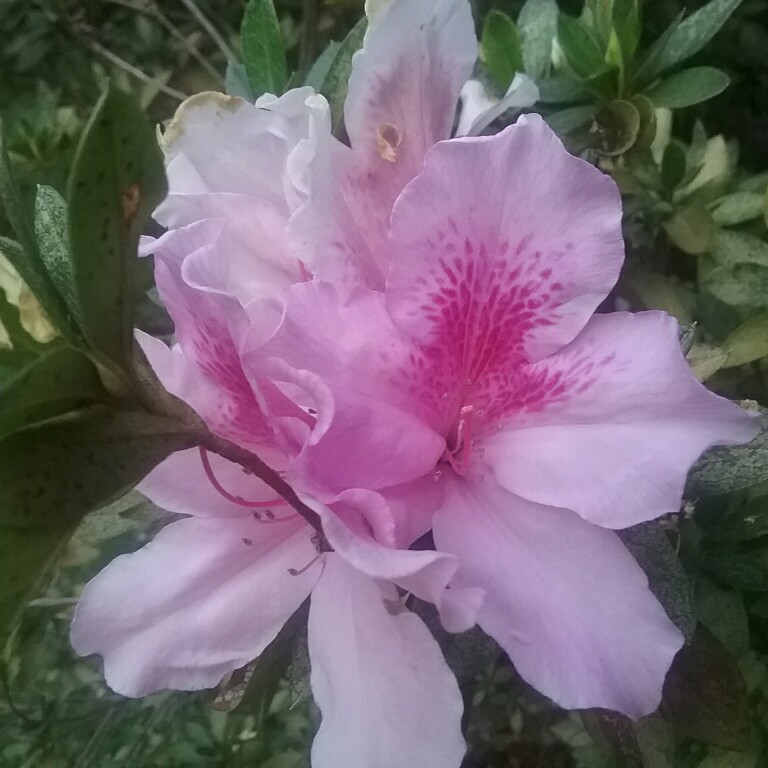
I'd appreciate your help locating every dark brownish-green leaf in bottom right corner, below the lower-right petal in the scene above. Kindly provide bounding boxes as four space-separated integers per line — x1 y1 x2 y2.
662 626 749 749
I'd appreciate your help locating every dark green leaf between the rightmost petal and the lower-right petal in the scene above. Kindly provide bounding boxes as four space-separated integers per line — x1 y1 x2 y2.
619 522 696 641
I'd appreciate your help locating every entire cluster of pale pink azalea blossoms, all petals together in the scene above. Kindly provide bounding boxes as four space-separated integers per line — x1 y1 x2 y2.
67 0 757 768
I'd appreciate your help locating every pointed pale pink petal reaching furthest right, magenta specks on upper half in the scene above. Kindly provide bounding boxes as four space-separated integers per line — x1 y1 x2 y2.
482 312 759 528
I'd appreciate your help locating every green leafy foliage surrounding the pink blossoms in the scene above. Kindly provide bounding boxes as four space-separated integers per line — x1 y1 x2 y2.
0 0 768 768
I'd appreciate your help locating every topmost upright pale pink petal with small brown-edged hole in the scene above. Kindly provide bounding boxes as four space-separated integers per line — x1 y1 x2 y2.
342 0 477 274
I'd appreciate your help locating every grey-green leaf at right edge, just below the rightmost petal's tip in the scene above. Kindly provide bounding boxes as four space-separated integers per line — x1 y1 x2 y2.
685 408 768 498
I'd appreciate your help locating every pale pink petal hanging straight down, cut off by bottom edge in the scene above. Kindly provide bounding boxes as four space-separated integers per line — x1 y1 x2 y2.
309 555 465 768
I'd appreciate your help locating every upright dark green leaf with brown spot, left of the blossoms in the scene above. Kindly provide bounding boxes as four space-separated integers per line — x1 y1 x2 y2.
68 87 167 369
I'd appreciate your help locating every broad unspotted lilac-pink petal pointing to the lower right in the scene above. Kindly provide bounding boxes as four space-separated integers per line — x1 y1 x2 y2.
434 477 683 717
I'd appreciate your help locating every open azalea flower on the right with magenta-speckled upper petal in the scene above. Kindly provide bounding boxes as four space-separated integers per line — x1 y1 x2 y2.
248 116 756 717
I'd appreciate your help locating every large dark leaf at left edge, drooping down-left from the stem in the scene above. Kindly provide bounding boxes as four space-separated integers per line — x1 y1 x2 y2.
0 407 196 638
